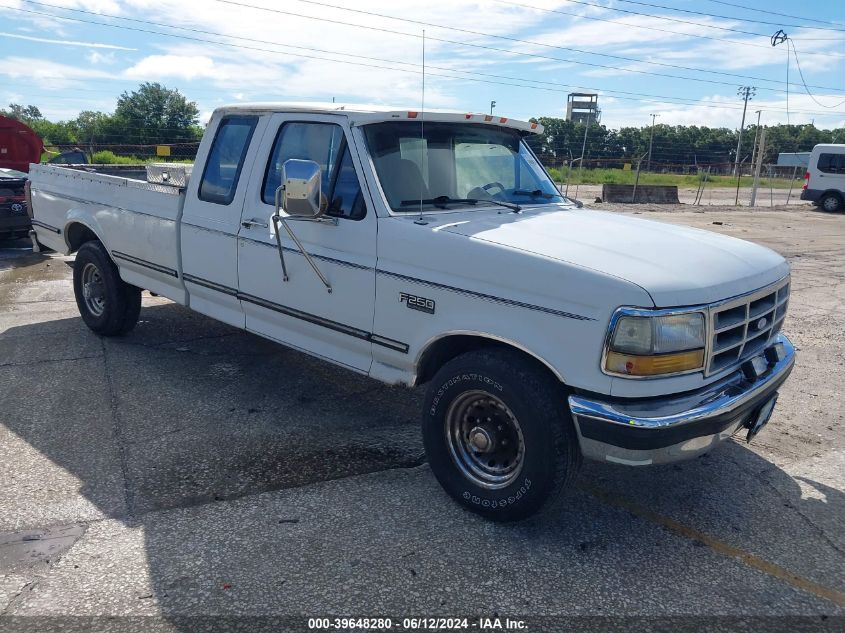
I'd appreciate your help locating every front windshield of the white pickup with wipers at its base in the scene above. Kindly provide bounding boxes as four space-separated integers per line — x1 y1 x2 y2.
364 121 564 212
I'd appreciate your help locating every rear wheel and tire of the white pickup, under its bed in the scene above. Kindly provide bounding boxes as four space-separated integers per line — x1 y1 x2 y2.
73 241 141 336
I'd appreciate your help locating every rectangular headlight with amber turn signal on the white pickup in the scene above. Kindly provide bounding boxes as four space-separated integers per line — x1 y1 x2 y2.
604 309 706 376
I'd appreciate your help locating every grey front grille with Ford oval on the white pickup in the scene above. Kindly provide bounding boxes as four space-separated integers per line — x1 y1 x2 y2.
707 277 789 376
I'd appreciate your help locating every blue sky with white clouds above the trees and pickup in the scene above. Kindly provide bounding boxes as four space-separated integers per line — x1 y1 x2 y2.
0 0 845 128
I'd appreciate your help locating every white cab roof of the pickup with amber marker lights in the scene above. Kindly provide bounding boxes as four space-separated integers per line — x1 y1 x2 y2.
214 102 543 134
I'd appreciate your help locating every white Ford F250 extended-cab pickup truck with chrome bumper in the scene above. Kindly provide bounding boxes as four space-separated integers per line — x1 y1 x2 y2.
24 104 794 520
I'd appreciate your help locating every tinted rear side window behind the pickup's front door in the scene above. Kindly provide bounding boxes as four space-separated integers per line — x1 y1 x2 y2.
199 116 258 205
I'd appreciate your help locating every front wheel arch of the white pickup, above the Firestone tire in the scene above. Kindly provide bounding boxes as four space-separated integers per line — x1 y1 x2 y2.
414 330 566 386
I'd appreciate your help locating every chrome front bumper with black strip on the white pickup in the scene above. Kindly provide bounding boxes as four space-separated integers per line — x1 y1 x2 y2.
569 334 795 466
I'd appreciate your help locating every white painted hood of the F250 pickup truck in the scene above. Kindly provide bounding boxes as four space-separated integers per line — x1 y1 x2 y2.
440 207 789 307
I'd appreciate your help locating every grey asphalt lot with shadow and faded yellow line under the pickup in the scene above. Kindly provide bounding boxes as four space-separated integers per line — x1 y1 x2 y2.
0 207 845 629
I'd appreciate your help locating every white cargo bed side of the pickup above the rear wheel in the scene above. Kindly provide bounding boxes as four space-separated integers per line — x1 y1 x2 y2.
29 165 190 300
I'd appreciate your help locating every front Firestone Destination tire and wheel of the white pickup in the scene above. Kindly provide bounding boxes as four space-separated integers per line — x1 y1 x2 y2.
423 348 581 521
